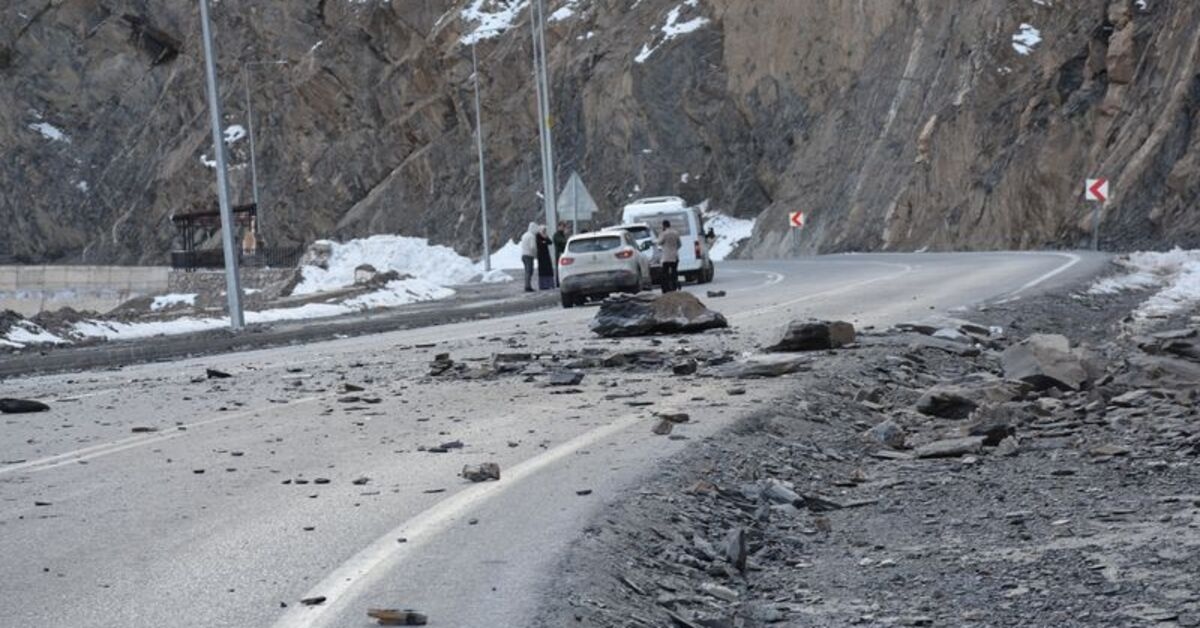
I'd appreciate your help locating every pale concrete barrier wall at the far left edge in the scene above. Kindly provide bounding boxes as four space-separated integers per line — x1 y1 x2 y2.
0 265 170 316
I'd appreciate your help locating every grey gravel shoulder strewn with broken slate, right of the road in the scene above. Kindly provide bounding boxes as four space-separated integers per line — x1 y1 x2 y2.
536 282 1200 627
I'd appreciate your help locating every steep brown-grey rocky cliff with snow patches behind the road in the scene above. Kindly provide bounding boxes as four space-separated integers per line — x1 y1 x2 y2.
0 0 1200 263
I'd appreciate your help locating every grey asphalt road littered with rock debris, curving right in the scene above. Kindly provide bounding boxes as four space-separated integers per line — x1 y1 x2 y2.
0 253 1108 628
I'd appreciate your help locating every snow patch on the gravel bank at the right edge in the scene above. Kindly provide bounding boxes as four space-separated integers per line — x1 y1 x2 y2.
1090 249 1200 319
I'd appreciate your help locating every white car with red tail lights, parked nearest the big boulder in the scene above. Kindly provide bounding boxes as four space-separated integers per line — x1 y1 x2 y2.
558 232 650 307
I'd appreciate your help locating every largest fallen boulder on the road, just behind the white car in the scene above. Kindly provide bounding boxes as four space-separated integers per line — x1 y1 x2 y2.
590 291 730 337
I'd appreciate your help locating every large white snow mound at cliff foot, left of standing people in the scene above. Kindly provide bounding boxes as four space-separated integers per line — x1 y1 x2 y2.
293 235 511 294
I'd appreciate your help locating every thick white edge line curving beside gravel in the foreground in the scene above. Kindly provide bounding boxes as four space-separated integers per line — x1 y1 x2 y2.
274 414 646 628
